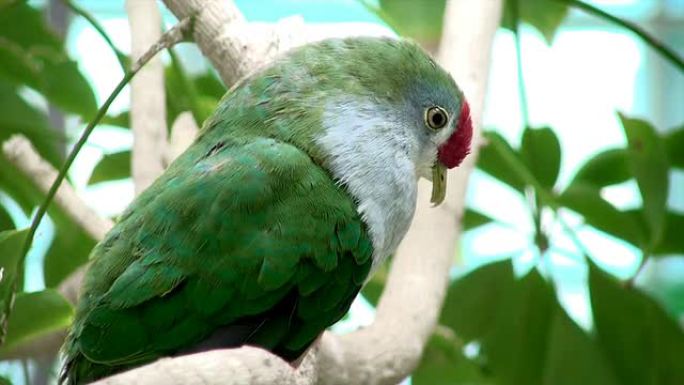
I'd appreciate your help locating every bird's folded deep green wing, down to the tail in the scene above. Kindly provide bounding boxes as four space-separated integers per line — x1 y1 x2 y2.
65 134 372 383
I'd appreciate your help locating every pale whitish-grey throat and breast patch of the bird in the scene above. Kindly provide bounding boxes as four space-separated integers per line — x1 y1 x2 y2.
317 101 417 267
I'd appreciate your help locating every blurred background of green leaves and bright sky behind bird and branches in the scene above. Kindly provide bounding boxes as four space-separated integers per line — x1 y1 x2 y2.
0 0 684 385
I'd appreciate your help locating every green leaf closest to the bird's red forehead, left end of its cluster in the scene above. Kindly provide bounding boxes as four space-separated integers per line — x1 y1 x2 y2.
477 131 525 192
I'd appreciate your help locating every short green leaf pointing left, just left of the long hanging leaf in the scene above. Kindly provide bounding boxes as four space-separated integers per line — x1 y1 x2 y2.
570 148 632 187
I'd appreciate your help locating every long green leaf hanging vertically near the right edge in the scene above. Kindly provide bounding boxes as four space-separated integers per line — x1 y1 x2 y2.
620 114 669 246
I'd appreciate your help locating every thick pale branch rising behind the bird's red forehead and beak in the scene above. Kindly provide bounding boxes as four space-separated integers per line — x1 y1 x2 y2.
320 0 501 384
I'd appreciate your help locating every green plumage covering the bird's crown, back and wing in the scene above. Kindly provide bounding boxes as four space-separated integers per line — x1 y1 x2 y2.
63 35 453 383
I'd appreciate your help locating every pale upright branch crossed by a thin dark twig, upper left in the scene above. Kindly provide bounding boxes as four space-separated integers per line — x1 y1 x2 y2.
126 0 166 194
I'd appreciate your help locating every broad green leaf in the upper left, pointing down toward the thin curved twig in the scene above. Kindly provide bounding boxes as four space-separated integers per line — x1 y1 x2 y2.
39 60 97 120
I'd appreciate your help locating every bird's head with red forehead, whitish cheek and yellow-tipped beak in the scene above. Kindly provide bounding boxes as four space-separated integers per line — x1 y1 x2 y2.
232 38 473 204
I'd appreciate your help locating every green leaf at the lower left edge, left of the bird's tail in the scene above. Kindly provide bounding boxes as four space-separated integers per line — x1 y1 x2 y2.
2 289 74 351
